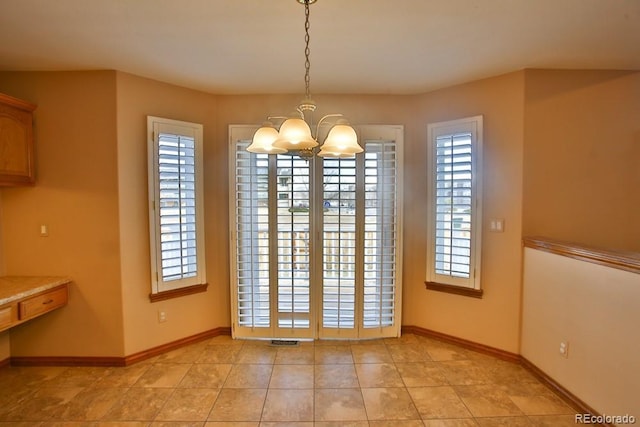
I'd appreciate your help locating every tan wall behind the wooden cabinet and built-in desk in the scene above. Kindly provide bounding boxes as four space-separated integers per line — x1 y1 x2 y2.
0 71 123 356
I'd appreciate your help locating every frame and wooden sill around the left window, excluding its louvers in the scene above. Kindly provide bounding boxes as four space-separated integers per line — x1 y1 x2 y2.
147 116 207 302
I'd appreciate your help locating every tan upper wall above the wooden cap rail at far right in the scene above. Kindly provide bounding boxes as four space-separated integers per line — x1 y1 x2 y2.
523 70 640 251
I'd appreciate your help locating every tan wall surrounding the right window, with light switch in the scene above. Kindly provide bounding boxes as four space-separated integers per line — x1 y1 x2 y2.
403 72 523 353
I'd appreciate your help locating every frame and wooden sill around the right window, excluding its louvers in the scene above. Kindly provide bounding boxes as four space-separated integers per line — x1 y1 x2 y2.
425 115 483 298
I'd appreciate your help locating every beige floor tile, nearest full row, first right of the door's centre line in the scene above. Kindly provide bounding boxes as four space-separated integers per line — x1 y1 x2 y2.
314 388 367 421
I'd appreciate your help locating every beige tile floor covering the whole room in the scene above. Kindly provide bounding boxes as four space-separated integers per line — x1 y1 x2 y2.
0 334 575 427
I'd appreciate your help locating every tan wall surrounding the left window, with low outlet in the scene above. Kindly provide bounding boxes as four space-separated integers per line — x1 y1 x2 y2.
117 73 230 355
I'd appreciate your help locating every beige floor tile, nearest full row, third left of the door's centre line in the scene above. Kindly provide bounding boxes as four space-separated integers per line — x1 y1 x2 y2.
155 388 220 422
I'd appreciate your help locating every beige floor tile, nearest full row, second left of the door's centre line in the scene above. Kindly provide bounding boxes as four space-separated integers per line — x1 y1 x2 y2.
208 388 267 421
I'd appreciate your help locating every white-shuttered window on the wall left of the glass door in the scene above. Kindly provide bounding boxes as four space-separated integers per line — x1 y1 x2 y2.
147 117 206 301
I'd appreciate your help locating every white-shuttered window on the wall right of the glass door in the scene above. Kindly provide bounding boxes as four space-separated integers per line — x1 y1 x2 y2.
427 116 482 297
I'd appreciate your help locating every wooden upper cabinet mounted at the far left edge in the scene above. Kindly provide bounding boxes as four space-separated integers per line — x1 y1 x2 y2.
0 93 36 186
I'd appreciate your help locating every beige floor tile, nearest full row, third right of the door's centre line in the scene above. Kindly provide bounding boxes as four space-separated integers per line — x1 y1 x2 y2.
407 386 472 419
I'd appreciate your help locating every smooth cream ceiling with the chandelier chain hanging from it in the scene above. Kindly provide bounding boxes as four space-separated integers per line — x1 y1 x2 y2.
0 0 640 94
